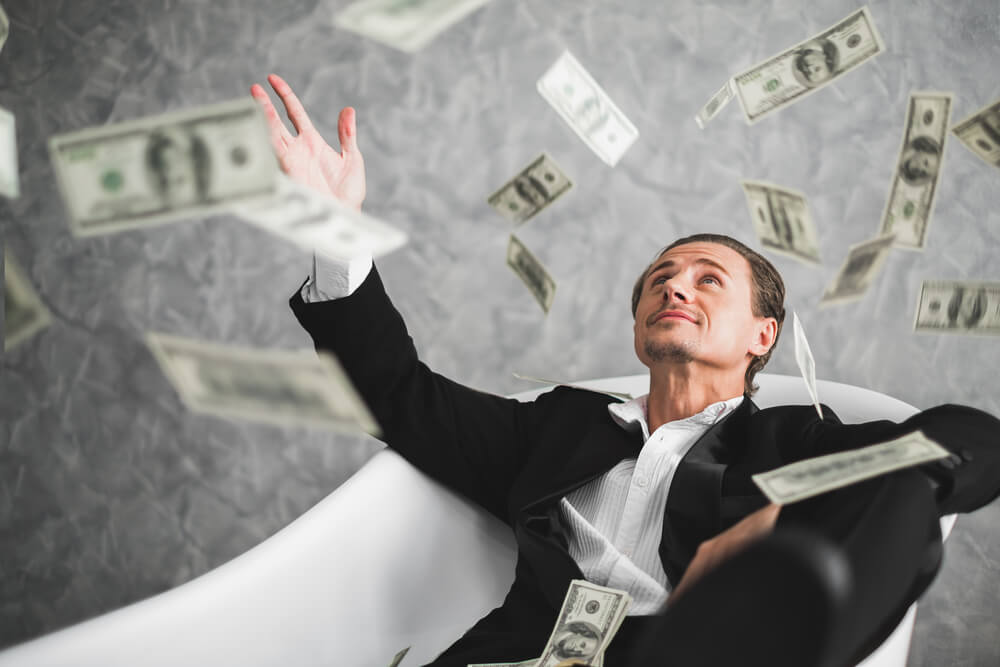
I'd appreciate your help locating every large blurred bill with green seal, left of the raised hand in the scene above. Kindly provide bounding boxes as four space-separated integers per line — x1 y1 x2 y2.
49 97 279 236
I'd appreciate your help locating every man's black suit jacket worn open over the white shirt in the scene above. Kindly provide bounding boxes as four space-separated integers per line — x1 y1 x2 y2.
290 268 1000 620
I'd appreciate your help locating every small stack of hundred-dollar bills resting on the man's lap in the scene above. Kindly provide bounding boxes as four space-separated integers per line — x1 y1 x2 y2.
537 579 632 667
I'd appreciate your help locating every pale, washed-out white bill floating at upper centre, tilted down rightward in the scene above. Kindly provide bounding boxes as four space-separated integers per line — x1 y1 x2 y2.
536 51 639 167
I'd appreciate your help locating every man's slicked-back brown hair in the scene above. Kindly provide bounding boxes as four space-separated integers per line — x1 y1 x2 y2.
632 234 785 396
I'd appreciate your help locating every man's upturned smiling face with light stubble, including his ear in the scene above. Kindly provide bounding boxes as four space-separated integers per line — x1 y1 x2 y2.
633 242 776 377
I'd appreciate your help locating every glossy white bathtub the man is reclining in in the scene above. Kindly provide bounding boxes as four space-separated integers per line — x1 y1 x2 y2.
0 374 954 667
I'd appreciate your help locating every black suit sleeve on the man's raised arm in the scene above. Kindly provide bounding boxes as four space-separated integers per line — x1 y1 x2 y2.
289 267 545 521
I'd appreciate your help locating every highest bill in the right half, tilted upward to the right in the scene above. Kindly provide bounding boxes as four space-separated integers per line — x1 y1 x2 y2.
733 7 885 123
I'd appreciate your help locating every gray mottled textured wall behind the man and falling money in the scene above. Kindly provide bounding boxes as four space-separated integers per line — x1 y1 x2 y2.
0 0 1000 666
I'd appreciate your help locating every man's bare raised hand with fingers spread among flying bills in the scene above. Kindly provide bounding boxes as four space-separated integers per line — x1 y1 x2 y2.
250 74 365 210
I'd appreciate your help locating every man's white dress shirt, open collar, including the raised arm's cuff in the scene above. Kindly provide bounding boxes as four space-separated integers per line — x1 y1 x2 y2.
302 255 743 616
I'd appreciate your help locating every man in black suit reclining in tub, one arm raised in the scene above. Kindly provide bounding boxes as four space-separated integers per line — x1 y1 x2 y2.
251 75 1000 666
